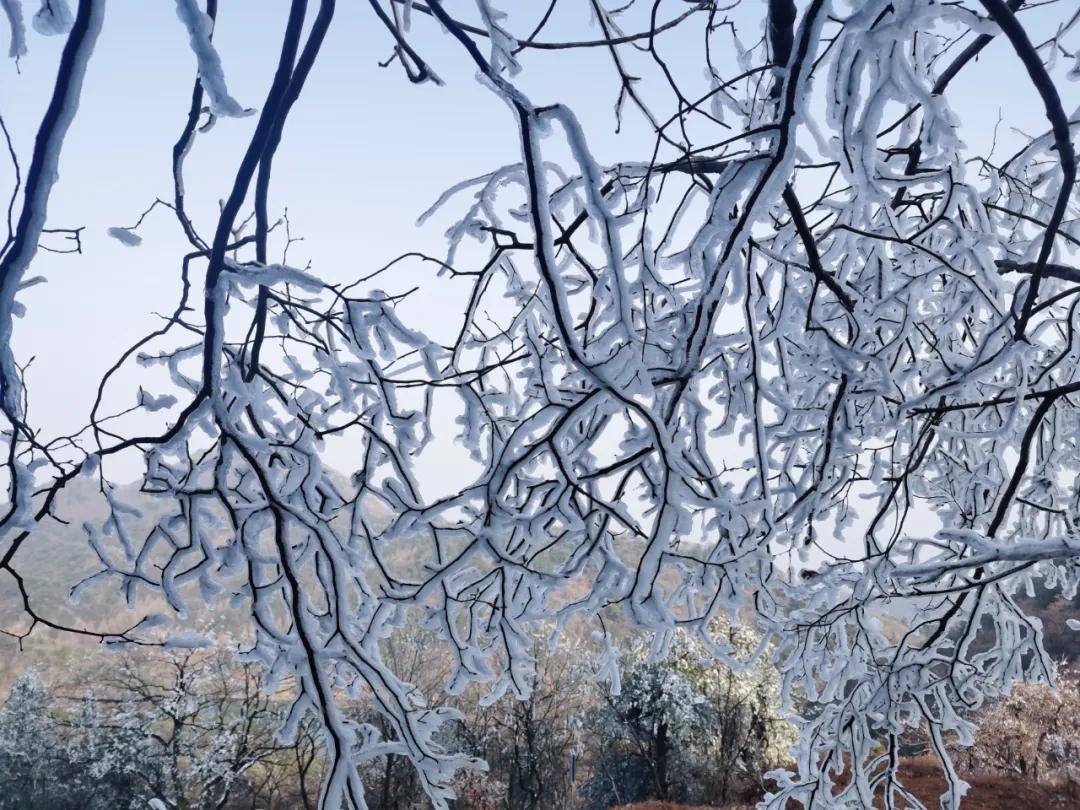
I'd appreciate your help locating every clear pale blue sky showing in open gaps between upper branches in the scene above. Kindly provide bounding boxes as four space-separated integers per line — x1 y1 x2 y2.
0 0 1080 481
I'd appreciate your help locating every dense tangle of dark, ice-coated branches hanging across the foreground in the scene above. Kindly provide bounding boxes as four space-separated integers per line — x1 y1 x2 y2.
0 0 1080 808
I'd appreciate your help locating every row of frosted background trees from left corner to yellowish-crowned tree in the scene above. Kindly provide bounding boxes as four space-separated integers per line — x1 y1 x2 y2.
0 631 794 810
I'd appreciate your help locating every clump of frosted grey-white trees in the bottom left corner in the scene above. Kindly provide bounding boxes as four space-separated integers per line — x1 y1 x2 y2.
0 650 330 810
